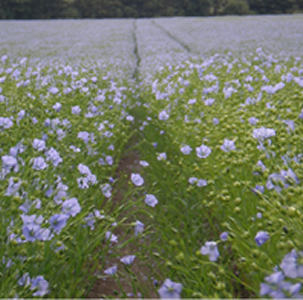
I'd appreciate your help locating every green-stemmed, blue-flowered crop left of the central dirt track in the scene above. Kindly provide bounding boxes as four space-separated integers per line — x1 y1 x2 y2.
0 56 140 298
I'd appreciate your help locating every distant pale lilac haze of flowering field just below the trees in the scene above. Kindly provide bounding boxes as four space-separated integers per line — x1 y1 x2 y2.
0 15 303 74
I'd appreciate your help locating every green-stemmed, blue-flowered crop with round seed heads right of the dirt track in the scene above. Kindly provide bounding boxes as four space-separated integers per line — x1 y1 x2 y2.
137 49 303 298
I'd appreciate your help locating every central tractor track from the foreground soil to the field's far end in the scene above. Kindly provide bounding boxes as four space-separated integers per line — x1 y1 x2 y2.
86 20 158 298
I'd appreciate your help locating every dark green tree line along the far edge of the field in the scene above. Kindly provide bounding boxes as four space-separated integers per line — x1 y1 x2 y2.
0 0 303 19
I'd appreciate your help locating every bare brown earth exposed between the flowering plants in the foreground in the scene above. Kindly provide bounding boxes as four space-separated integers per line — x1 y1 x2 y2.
87 143 158 298
